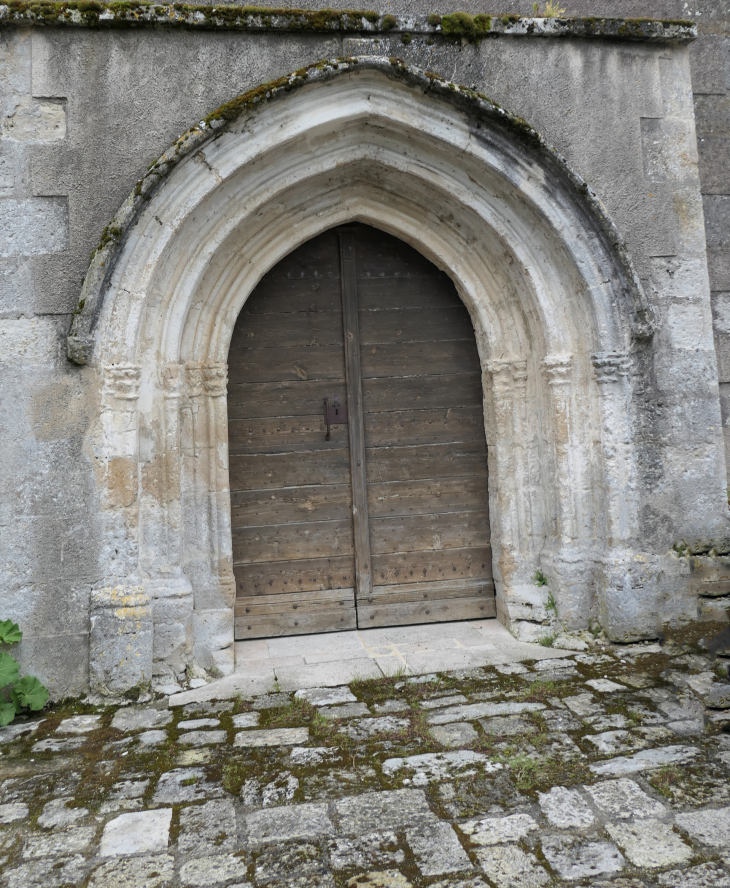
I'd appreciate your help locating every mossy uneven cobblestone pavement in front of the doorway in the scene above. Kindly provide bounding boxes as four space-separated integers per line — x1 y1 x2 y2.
0 628 730 888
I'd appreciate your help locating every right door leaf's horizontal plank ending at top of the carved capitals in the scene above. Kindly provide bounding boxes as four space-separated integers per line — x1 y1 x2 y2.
360 342 481 379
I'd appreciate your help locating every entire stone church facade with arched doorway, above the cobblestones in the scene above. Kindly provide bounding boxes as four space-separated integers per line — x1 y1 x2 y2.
0 0 730 697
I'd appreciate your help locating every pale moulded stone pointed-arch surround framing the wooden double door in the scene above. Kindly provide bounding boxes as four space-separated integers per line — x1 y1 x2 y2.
69 58 655 692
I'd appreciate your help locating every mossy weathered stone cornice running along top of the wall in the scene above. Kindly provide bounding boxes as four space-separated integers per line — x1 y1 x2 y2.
0 0 697 43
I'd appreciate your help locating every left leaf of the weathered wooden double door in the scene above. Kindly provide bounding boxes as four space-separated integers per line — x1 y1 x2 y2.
228 231 357 639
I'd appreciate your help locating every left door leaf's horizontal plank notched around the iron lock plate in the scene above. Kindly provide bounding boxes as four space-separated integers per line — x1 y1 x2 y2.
228 379 347 420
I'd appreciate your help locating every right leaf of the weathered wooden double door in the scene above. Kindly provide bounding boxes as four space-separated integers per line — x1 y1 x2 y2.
354 226 495 628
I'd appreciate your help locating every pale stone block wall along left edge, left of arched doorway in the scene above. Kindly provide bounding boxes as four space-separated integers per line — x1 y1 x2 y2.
0 31 91 697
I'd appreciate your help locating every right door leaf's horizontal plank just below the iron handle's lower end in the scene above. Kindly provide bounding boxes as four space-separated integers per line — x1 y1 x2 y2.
362 441 487 483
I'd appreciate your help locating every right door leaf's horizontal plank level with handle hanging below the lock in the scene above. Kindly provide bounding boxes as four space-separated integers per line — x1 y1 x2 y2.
365 407 484 447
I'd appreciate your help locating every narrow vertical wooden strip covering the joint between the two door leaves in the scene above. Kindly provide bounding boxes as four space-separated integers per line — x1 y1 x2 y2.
339 230 373 601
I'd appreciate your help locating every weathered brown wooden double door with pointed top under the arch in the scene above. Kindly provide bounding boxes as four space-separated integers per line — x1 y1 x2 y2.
228 225 495 639
